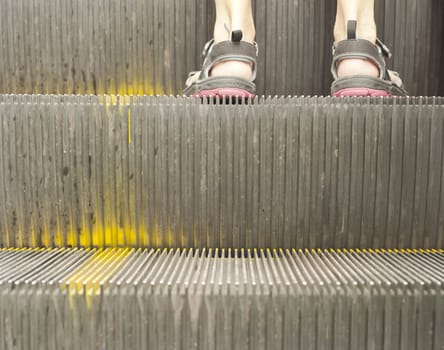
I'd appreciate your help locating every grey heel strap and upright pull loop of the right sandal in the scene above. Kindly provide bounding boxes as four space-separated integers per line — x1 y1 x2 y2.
331 21 391 80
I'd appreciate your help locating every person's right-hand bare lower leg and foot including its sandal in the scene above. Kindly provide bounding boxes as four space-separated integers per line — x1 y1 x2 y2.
332 0 407 96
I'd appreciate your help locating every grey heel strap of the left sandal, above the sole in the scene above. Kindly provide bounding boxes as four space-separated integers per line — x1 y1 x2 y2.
200 31 258 81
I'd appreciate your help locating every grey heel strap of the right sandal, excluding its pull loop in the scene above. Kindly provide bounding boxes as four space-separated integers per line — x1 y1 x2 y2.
331 39 386 80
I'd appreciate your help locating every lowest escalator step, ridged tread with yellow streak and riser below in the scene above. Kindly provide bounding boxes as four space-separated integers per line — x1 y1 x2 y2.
0 249 444 350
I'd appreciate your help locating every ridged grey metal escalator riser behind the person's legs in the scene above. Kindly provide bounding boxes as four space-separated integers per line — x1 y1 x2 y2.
0 0 444 95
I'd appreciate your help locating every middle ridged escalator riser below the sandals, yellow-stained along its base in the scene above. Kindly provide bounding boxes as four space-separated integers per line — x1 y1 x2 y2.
0 95 444 248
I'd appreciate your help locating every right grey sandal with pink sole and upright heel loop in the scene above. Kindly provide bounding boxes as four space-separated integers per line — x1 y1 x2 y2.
331 21 407 97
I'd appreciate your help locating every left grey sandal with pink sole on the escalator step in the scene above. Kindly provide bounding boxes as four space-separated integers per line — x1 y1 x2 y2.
183 30 258 98
